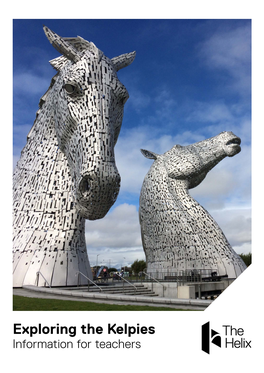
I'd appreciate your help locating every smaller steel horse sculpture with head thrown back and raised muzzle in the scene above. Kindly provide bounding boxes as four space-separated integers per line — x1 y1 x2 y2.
139 132 245 278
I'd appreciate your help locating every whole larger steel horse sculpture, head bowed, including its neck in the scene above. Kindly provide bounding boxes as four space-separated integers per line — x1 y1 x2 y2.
13 27 135 287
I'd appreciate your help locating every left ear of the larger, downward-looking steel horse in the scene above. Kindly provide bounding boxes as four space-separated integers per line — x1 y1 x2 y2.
43 26 81 62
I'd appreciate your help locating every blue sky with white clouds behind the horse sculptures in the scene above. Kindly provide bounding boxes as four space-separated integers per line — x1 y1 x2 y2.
13 19 251 267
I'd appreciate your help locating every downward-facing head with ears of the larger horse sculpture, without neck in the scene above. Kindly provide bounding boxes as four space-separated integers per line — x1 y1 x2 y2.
44 26 135 220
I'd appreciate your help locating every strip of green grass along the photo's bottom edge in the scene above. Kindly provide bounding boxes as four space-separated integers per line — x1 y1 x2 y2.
13 295 192 311
